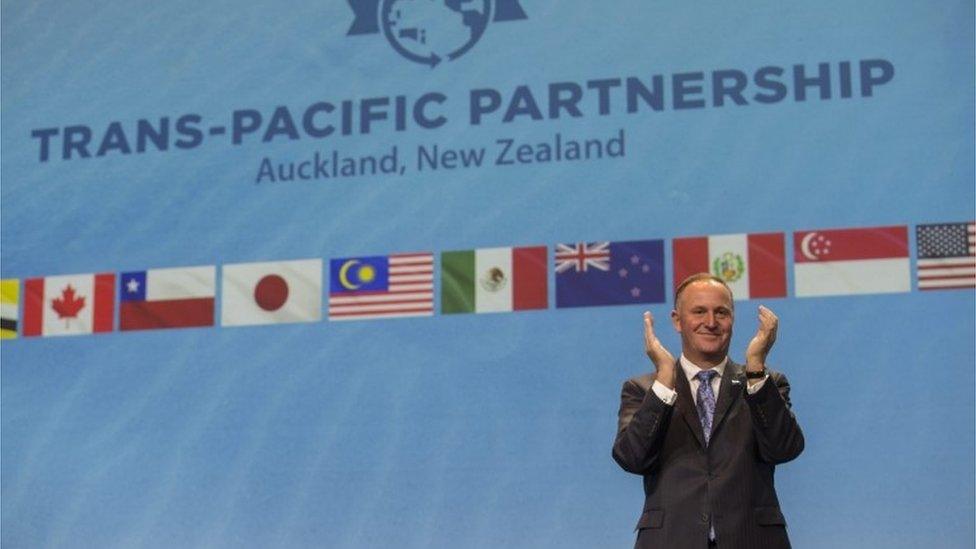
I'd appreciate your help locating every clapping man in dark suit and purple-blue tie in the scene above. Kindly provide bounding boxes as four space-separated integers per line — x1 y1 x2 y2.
613 273 803 549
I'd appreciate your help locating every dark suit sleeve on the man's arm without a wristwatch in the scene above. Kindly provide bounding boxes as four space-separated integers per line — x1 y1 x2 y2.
613 379 674 475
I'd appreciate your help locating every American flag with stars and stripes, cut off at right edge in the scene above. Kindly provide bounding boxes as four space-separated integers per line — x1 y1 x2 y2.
915 221 976 290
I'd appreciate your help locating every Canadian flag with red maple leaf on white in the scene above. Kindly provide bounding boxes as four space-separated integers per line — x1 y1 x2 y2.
24 273 115 337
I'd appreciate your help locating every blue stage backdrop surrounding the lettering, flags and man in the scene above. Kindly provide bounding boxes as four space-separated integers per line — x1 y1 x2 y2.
0 0 976 548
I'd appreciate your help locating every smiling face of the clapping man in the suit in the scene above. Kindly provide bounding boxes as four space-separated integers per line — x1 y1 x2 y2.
671 280 734 366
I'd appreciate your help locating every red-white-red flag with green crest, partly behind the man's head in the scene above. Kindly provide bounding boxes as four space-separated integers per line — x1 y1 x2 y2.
673 233 786 299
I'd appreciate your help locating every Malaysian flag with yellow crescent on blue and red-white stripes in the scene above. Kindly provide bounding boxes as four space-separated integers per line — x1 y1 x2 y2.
329 252 434 320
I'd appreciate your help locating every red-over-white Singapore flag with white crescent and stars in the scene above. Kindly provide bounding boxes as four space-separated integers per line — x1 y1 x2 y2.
793 225 911 297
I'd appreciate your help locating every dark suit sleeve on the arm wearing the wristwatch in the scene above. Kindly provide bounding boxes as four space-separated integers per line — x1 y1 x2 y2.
746 372 804 465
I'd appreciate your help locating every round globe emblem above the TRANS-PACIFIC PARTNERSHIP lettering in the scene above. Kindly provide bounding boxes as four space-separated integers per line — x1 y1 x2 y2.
379 0 492 68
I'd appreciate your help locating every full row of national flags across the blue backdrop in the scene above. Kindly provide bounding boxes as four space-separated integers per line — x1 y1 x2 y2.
0 222 976 338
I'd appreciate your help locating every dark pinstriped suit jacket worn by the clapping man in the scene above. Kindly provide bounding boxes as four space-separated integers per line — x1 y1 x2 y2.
613 361 804 549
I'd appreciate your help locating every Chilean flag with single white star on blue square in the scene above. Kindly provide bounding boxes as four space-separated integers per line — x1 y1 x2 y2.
119 266 217 331
